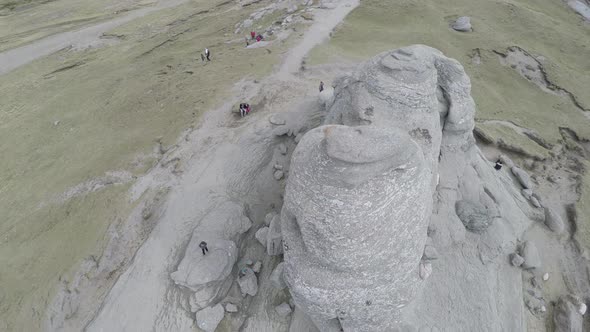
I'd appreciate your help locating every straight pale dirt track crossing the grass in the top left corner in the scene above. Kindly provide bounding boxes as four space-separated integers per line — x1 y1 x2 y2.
0 0 187 75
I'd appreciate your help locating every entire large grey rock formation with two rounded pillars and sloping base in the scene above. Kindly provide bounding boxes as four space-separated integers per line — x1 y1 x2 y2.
281 45 544 331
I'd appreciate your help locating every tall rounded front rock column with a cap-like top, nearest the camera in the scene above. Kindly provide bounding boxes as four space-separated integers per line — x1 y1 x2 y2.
282 125 432 331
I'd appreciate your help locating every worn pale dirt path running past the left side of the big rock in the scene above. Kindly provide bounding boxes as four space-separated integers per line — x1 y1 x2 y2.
81 0 358 331
